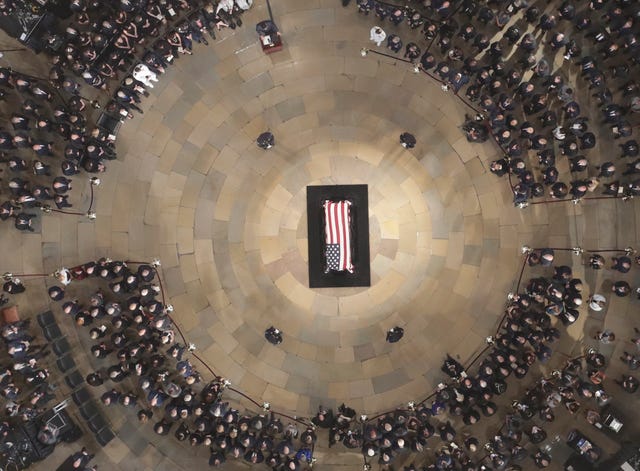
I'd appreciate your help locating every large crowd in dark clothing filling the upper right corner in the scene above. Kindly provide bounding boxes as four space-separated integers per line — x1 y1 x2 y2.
357 0 640 206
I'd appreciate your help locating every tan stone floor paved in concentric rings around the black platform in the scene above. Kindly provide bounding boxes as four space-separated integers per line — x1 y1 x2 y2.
1 0 640 470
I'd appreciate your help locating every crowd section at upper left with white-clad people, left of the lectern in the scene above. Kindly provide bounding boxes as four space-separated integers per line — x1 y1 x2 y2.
40 0 252 106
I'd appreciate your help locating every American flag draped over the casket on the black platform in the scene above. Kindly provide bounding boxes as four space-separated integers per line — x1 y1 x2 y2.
324 200 353 273
